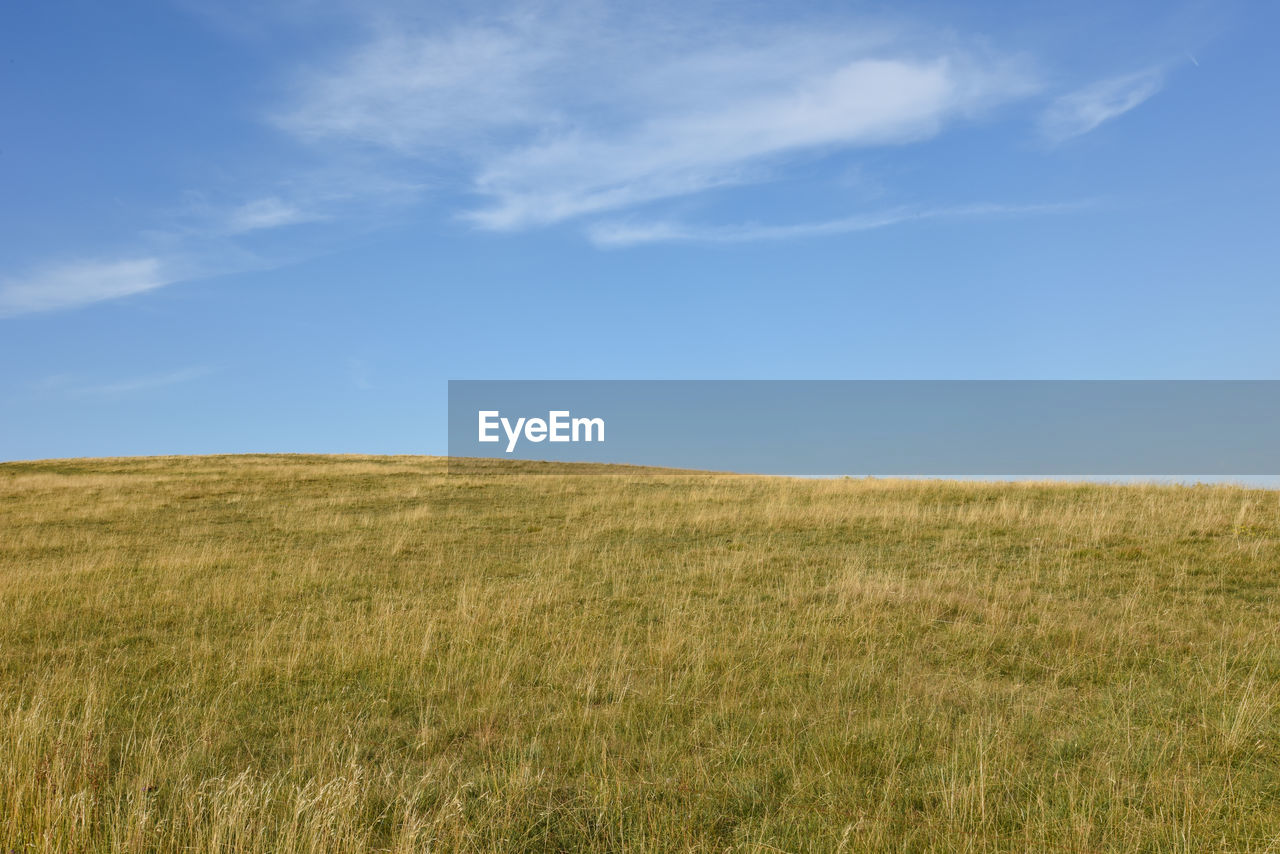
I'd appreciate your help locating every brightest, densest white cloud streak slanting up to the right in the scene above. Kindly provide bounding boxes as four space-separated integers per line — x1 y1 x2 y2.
471 58 1039 229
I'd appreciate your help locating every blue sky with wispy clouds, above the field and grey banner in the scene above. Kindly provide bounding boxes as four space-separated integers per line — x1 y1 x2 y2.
0 0 1280 460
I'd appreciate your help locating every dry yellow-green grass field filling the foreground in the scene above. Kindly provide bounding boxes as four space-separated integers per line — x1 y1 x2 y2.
0 456 1280 854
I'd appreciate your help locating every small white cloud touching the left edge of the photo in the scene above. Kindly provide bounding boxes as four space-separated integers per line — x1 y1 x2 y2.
0 257 177 316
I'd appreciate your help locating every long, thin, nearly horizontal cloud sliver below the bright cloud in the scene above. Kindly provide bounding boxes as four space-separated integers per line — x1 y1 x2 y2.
588 202 1092 248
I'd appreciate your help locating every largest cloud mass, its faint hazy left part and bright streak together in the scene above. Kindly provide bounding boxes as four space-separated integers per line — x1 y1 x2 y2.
276 12 1036 229
